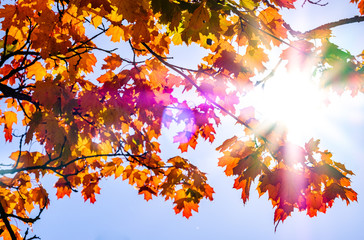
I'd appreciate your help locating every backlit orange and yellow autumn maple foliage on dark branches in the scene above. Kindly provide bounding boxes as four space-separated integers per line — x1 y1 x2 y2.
0 0 364 240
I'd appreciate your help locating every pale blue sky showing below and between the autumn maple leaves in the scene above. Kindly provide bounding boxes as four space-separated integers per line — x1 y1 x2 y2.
0 0 364 240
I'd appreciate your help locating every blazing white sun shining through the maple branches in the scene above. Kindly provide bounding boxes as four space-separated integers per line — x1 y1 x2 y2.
252 67 326 143
